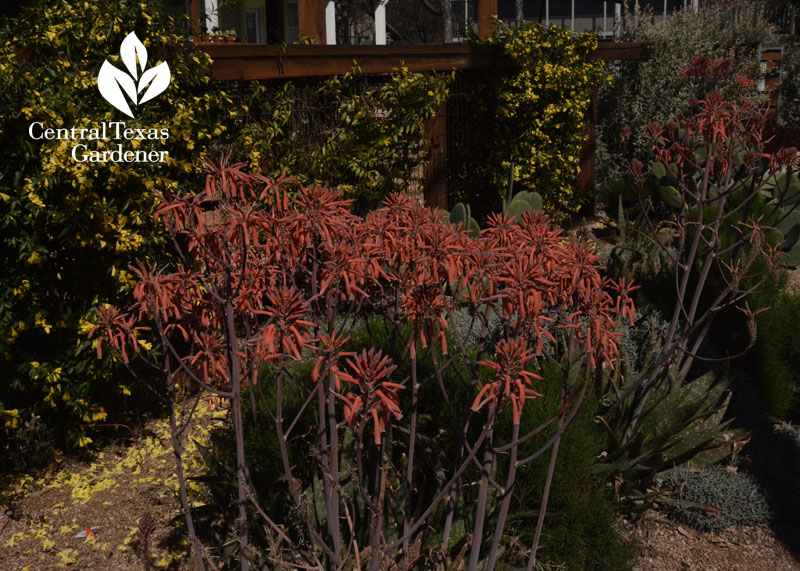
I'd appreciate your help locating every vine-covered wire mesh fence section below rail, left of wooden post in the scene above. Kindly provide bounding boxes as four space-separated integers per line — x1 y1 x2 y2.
206 74 440 205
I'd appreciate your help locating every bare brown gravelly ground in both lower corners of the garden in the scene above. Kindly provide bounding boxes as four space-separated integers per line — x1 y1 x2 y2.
0 398 800 571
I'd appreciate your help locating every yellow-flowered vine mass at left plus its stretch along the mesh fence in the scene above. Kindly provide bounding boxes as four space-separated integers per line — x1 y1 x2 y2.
0 0 460 456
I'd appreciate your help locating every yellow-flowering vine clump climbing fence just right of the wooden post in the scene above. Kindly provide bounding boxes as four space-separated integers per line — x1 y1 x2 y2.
454 23 610 216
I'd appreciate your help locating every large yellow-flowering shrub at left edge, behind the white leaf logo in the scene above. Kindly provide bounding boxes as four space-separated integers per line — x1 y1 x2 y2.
0 0 230 452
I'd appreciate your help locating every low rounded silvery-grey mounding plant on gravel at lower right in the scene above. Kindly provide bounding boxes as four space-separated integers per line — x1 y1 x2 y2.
664 466 770 531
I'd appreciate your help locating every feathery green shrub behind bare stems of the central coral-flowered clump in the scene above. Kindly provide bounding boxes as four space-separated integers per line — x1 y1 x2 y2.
194 340 635 571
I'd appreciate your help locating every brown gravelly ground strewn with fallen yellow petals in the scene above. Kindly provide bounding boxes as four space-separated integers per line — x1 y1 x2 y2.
0 405 223 571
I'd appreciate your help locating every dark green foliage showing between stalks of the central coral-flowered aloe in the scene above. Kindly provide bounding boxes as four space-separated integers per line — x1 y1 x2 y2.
194 320 635 571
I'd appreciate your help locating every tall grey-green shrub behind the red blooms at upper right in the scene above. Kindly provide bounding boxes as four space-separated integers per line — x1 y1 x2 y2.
597 0 780 183
